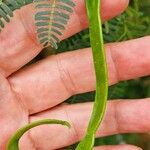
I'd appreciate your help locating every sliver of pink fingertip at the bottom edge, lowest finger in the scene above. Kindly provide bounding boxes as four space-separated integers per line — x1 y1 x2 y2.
94 145 142 150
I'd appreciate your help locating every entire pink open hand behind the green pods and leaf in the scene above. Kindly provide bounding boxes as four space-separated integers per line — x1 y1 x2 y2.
0 0 150 150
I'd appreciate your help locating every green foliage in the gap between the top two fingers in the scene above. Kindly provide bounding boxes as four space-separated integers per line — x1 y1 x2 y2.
58 0 150 52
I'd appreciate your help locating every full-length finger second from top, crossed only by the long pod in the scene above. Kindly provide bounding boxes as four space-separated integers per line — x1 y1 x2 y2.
9 37 150 114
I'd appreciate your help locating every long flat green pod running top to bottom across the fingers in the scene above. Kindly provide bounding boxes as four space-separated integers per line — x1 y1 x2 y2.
76 0 108 150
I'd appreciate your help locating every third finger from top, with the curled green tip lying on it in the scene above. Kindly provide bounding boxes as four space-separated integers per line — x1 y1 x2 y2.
19 98 150 149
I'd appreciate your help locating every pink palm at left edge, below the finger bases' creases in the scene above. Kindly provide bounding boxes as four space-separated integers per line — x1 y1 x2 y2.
0 75 28 149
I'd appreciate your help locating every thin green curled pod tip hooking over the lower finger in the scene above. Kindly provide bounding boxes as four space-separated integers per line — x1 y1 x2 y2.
7 119 70 150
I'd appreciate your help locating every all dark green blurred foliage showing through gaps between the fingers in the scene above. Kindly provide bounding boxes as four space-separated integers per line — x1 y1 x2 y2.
33 0 150 150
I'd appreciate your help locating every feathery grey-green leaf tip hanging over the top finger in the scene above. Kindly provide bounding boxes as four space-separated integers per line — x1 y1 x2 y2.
34 0 75 49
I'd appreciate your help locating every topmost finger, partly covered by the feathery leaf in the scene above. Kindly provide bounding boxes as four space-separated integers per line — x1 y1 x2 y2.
0 0 128 76
